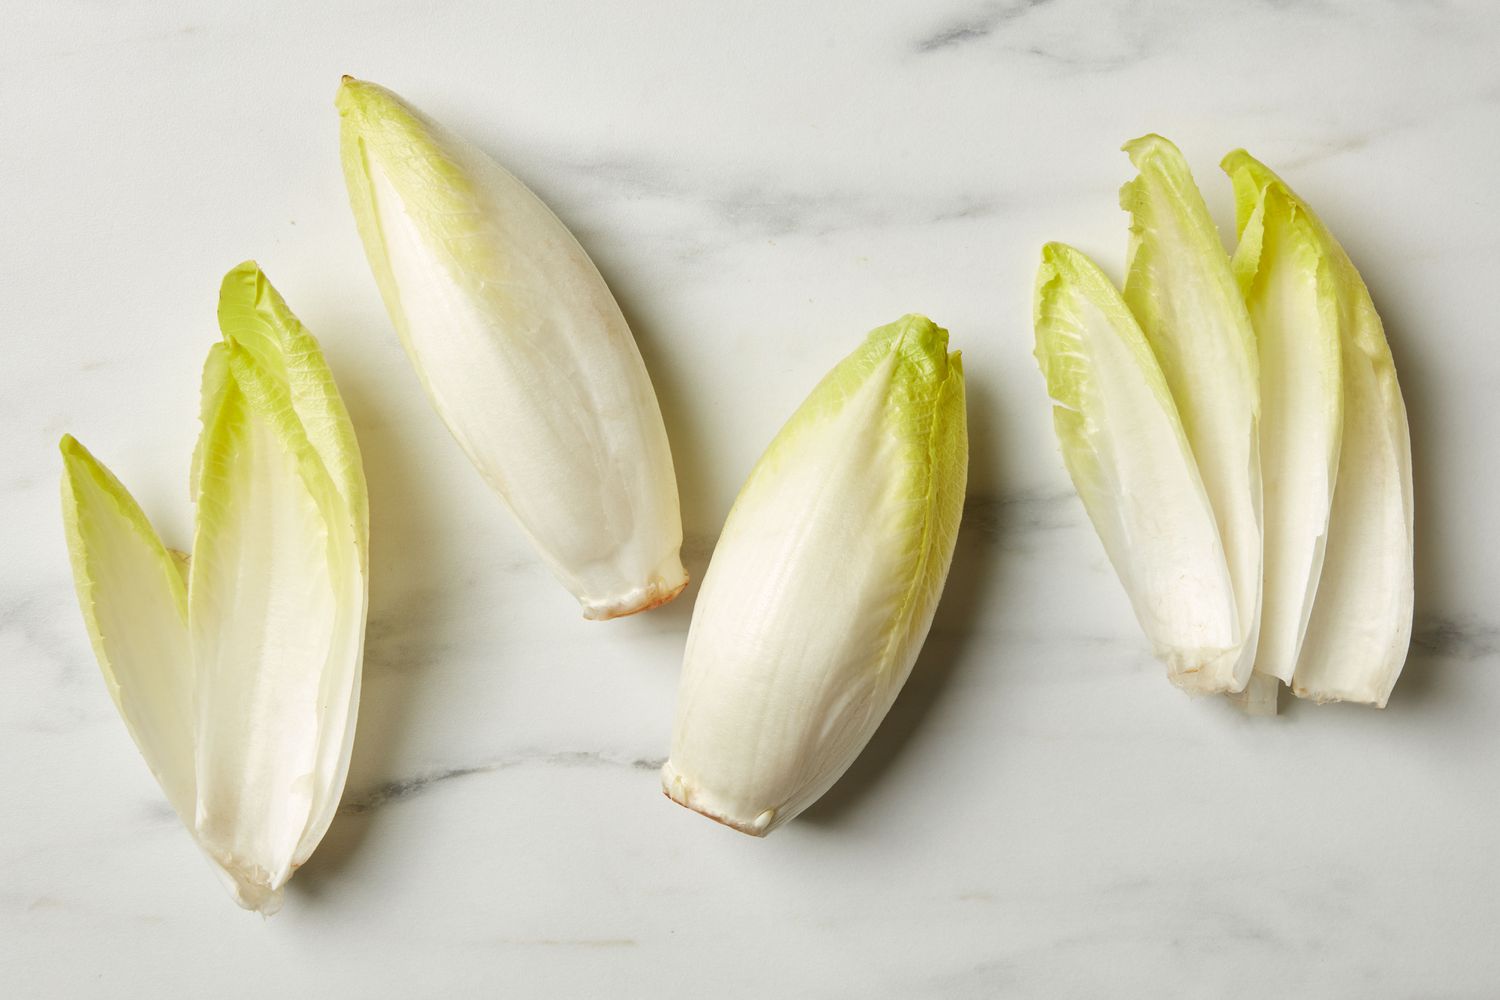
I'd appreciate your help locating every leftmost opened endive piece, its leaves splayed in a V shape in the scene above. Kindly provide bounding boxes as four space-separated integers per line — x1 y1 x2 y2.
62 264 369 913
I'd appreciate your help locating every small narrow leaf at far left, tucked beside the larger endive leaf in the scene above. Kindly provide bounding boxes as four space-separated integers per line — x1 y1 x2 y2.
62 436 195 825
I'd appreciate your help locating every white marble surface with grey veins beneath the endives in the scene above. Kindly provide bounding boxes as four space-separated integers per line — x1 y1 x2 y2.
0 0 1500 999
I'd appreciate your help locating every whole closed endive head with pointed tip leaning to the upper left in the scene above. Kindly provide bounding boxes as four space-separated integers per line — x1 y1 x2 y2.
338 78 687 619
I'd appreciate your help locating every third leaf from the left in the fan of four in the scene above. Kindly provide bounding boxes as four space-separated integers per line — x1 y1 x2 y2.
1235 172 1343 684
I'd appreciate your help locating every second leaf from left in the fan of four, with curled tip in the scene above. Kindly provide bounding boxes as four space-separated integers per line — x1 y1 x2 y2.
1121 135 1262 693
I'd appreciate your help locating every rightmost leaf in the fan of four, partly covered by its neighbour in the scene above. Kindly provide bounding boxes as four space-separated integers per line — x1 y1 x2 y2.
1224 150 1413 706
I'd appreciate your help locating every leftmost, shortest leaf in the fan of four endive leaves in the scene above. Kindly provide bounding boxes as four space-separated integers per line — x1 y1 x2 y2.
1035 243 1241 680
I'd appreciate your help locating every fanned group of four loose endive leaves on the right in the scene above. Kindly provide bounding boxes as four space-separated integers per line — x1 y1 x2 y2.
1035 135 1413 712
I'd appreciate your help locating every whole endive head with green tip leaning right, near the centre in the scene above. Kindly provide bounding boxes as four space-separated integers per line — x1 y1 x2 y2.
662 316 968 835
